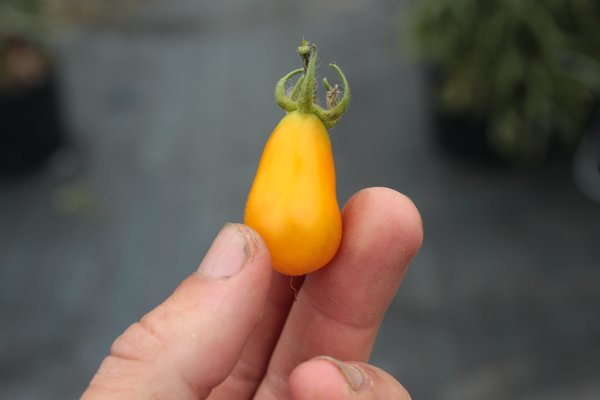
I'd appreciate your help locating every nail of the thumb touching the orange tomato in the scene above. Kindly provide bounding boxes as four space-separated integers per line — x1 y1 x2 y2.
198 224 250 279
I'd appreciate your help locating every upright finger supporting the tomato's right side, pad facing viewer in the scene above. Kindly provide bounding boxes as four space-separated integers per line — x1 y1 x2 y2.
257 188 423 399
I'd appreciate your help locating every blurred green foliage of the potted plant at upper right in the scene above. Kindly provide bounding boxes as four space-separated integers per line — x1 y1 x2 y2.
411 0 600 159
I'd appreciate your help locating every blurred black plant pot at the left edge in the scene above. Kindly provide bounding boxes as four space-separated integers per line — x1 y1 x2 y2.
0 70 65 176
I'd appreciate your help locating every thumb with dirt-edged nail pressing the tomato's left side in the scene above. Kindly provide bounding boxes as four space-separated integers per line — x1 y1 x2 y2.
83 224 271 399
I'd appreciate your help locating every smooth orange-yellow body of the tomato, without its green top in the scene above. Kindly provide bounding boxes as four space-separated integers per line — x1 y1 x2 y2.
244 111 342 275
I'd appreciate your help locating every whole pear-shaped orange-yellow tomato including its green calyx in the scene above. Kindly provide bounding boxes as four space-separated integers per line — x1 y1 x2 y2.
244 40 350 275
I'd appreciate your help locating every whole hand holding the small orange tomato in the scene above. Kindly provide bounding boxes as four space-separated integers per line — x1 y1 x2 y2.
82 188 423 400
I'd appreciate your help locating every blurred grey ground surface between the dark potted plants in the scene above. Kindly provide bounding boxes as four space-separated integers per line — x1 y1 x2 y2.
0 0 600 400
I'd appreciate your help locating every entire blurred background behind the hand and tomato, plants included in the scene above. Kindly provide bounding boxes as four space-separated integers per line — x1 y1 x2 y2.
0 0 600 400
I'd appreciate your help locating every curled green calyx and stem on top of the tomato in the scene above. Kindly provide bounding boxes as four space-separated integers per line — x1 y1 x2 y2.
275 40 350 128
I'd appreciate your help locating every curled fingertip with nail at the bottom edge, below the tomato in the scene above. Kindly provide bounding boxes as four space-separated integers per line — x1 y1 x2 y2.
289 357 410 400
